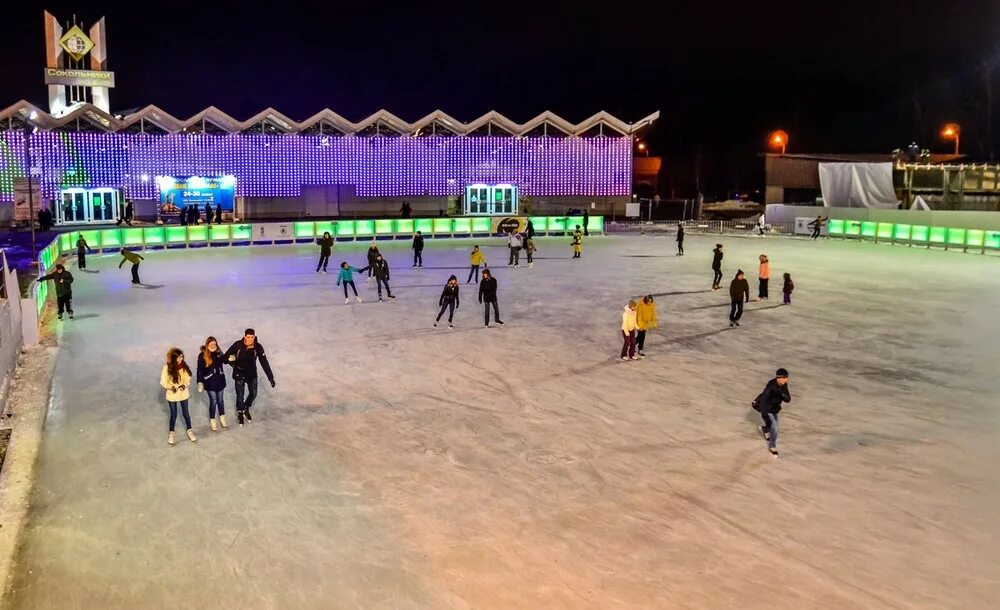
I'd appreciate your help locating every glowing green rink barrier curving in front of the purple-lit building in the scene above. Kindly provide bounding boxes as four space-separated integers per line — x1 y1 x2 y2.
31 216 604 320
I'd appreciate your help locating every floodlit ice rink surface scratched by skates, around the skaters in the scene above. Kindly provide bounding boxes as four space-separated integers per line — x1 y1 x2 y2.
3 235 1000 610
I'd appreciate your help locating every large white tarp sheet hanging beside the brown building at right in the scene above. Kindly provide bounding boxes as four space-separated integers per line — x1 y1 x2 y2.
819 163 899 209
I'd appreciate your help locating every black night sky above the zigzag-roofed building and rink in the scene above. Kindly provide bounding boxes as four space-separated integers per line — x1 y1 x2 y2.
0 0 1000 196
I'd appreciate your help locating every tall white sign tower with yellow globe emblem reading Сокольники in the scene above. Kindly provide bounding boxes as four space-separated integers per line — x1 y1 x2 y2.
45 11 115 116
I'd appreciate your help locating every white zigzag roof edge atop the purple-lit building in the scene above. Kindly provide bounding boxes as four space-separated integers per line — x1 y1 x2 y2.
0 100 660 136
